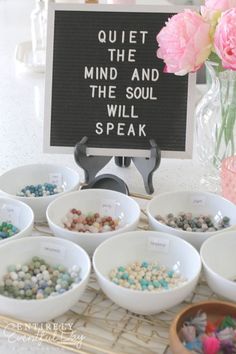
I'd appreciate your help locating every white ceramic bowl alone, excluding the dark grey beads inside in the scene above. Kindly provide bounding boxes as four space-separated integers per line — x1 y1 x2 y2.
147 191 236 250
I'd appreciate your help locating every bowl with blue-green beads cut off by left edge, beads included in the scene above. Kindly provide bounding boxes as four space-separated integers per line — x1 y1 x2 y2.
0 197 34 245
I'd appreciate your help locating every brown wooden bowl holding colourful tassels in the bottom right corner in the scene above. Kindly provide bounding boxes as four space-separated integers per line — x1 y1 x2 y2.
169 300 236 354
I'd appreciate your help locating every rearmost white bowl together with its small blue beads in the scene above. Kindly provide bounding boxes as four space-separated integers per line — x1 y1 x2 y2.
0 164 80 222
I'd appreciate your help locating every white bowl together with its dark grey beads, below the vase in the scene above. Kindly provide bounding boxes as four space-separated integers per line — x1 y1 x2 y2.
147 191 236 250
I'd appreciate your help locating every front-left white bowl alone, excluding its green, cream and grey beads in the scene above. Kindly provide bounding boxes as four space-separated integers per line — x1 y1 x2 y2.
0 236 91 322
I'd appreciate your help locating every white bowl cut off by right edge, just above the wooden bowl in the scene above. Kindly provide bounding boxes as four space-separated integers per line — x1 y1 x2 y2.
200 230 236 302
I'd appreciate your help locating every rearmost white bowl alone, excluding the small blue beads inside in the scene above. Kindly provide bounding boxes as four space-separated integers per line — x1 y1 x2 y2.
0 164 79 222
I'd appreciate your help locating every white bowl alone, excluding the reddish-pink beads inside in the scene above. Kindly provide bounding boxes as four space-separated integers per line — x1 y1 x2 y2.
46 189 140 254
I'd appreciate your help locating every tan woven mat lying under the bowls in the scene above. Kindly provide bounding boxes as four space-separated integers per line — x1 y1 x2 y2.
0 205 225 354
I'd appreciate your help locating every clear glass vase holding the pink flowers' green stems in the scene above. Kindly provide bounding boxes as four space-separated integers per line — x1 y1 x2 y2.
196 62 236 192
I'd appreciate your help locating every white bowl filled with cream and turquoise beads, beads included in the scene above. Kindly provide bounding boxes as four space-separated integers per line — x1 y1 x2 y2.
93 231 201 315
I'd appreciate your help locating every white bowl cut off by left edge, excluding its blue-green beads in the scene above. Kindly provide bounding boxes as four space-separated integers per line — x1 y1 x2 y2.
0 197 34 246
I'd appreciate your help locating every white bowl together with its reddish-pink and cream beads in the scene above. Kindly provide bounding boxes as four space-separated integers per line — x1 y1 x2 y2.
46 189 140 254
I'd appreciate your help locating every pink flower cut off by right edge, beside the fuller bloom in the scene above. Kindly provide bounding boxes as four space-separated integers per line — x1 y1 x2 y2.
214 8 236 70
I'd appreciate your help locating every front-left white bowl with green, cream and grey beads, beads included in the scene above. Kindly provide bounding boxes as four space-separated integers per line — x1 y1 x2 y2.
0 236 91 322
